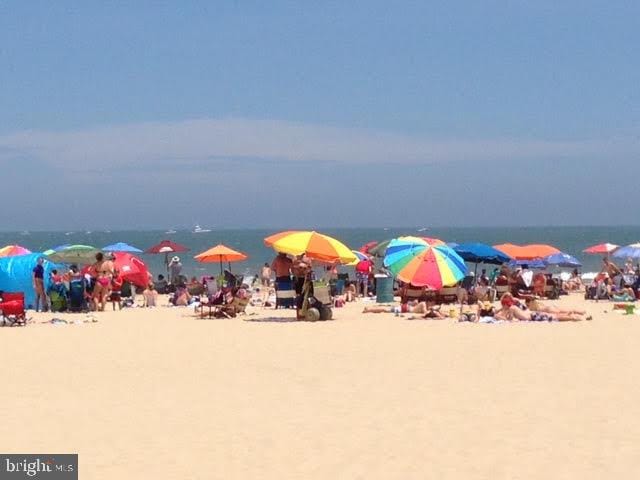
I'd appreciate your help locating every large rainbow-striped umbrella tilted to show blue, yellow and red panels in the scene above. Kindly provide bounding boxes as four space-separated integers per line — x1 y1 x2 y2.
384 237 467 289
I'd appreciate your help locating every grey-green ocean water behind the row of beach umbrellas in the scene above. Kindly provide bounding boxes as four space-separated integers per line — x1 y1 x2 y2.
0 226 640 277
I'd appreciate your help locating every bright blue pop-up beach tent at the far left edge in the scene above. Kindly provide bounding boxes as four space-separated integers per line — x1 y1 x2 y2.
0 253 56 308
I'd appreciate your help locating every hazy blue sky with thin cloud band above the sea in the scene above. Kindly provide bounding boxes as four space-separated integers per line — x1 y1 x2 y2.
0 0 640 230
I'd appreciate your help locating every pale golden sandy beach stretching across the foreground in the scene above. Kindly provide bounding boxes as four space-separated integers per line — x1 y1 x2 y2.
0 295 640 479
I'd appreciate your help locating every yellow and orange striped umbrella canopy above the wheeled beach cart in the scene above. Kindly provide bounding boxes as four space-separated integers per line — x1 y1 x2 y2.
264 230 356 264
